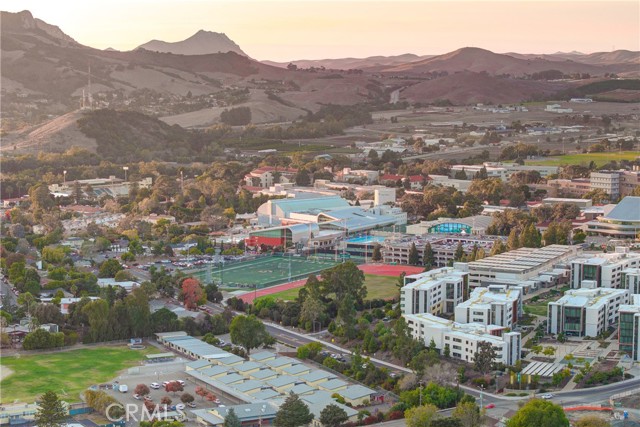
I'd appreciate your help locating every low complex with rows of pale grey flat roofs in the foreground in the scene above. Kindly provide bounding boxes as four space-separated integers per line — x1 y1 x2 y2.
156 331 370 425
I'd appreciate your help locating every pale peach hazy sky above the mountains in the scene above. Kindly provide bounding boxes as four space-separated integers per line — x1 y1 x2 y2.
1 0 640 61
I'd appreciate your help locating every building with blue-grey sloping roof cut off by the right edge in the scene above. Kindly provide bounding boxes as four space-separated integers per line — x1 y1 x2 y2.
586 196 640 239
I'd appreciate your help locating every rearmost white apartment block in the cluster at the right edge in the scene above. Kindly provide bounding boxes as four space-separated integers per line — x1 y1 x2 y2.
571 251 640 293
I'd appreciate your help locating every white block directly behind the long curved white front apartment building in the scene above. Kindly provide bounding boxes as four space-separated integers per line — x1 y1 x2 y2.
455 285 522 329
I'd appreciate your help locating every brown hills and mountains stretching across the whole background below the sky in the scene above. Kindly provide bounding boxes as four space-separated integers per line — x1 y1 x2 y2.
0 11 640 154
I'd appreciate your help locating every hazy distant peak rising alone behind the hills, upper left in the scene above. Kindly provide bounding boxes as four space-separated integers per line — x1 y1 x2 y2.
136 30 247 56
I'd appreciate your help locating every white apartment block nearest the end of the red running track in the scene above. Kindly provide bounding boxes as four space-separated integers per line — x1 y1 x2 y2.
400 267 468 314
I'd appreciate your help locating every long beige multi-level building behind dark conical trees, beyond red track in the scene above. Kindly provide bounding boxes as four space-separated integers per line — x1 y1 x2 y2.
382 234 500 267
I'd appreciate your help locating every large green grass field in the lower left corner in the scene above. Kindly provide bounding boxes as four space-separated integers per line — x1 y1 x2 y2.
0 347 158 403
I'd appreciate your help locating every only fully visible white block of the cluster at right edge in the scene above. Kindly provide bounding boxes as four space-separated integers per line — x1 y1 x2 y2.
547 288 629 337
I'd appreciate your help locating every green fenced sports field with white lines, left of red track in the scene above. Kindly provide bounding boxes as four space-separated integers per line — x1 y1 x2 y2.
189 256 340 289
